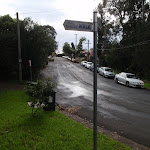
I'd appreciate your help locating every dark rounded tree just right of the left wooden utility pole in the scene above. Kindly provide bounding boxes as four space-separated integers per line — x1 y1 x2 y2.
21 18 57 76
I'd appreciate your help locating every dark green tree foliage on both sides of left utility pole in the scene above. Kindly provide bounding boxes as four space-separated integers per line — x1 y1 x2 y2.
0 15 57 79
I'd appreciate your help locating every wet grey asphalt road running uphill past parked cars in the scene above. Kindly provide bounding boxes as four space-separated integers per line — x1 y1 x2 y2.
42 57 150 147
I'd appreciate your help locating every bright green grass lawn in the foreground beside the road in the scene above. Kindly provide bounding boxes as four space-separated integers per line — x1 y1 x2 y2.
0 90 130 150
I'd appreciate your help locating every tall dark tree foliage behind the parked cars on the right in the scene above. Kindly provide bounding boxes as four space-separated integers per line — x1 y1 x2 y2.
98 0 150 79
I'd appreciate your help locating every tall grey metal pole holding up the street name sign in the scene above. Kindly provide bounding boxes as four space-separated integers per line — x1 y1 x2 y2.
93 11 97 150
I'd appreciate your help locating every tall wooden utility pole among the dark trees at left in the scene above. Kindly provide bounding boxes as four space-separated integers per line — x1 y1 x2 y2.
16 12 22 82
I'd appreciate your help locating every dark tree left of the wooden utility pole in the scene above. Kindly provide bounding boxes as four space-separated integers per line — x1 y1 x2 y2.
0 15 17 77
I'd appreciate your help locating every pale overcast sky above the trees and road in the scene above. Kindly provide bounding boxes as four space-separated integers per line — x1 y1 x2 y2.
0 0 101 52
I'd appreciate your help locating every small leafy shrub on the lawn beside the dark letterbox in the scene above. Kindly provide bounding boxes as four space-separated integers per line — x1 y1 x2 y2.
26 77 56 114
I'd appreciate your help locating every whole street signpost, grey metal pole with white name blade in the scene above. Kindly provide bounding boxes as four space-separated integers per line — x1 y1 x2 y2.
63 11 97 150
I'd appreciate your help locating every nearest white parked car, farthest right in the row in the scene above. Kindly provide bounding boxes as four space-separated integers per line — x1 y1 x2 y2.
114 72 144 88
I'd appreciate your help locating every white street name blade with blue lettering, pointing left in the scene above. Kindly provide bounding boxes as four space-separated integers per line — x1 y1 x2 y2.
63 20 93 32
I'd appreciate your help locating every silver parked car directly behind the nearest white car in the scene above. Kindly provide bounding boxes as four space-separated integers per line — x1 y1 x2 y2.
98 67 115 78
